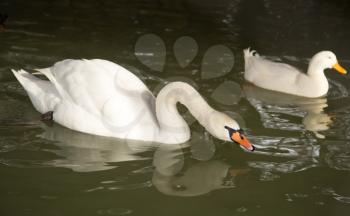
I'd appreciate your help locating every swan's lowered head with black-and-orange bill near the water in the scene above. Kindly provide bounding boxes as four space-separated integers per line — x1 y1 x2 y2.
208 112 255 151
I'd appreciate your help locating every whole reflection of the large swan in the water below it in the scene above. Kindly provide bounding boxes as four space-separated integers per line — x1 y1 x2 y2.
41 124 249 196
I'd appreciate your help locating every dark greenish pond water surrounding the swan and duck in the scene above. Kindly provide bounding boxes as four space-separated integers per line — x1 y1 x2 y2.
0 0 350 216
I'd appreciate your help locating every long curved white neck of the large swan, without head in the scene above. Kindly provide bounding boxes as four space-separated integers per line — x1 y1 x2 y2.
156 82 214 143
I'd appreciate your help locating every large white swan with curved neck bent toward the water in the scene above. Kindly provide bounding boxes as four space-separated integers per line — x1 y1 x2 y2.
12 59 254 151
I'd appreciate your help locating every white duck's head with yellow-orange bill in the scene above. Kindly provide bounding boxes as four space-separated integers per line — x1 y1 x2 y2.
312 51 346 74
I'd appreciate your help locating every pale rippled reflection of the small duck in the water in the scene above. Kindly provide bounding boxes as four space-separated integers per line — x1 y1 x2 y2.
243 83 332 139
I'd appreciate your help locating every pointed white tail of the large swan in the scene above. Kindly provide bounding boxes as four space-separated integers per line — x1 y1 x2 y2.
11 69 60 113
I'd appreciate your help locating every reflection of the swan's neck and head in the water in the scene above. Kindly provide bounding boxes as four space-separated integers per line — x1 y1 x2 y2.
152 140 250 196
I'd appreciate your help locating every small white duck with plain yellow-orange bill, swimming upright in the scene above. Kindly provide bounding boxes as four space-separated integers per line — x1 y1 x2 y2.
243 48 346 98
